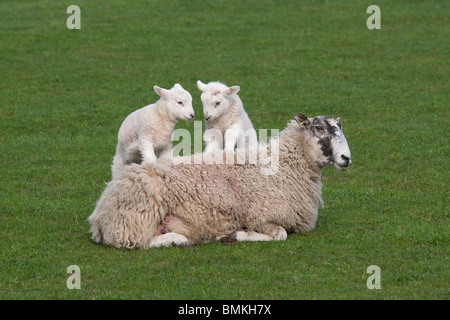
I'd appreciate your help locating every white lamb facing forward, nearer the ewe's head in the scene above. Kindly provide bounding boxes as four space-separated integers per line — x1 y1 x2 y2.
197 80 257 152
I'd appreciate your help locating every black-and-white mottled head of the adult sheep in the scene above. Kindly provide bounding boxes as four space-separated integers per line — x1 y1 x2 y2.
295 113 352 170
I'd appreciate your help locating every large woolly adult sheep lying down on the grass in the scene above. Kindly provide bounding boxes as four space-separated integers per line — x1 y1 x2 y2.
88 114 351 248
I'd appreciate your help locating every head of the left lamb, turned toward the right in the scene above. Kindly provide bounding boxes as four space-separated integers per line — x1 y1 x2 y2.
153 83 194 121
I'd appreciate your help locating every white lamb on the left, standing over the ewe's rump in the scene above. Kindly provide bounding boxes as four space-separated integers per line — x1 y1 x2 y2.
112 83 194 179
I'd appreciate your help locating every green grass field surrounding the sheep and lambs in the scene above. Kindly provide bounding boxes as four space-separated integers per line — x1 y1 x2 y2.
0 0 450 299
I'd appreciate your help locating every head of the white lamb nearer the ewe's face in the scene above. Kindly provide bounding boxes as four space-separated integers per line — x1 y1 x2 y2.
197 80 240 121
